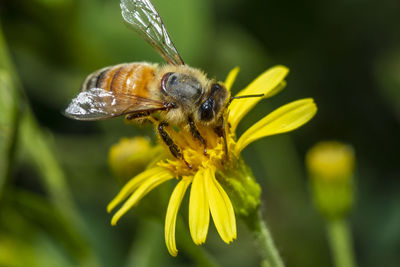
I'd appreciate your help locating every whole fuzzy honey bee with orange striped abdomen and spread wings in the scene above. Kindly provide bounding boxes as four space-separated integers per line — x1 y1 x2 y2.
65 0 255 164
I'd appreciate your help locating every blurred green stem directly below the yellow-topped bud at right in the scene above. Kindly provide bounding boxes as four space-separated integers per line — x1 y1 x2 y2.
327 219 356 267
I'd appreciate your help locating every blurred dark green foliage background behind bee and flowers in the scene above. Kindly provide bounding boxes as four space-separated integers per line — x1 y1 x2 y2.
0 0 400 266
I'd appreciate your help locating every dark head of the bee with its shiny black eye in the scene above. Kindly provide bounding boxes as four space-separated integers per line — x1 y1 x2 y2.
198 83 229 122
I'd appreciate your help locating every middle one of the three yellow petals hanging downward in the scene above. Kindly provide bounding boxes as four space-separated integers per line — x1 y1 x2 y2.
189 168 210 245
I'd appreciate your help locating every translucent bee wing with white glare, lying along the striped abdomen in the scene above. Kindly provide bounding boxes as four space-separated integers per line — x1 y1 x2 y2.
64 88 166 121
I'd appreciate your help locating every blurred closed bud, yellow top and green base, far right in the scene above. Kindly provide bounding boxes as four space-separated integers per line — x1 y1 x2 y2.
306 142 355 219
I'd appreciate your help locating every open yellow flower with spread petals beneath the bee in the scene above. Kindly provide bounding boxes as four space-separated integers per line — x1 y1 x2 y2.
107 66 317 256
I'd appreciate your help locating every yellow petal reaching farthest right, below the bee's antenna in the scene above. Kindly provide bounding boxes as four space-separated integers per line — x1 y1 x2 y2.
235 98 317 153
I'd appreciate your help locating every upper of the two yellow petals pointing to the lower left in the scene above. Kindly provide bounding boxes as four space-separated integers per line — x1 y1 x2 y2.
107 167 171 212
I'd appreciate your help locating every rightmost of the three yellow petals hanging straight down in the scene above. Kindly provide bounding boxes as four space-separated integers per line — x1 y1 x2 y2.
204 168 236 243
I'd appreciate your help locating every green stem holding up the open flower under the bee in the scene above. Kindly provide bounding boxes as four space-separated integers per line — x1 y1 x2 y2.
245 210 285 267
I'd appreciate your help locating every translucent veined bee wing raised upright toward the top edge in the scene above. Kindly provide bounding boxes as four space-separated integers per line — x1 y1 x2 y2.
120 0 184 65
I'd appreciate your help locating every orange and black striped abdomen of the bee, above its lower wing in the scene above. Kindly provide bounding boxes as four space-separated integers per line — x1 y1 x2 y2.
82 63 156 97
